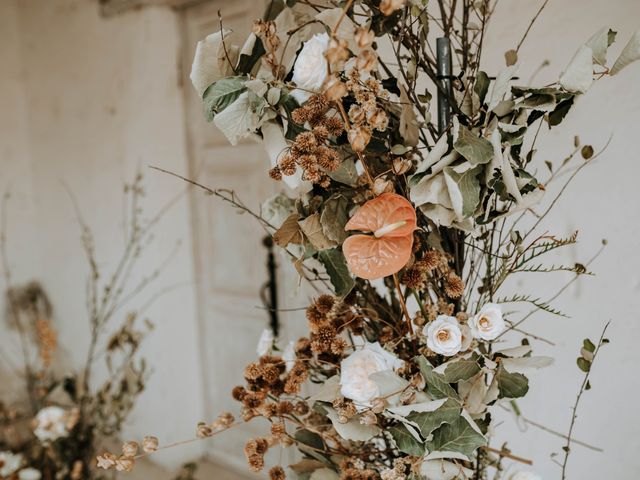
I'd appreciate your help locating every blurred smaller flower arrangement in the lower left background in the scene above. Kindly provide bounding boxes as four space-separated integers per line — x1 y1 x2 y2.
0 176 180 480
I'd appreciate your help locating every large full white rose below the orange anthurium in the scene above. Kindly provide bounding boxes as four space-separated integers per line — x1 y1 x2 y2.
340 342 404 407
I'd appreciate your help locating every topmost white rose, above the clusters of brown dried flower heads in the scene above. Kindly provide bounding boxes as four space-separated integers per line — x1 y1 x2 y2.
291 33 329 104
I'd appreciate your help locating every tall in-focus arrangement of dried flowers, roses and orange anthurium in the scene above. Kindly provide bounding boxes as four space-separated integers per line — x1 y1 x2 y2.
99 0 640 480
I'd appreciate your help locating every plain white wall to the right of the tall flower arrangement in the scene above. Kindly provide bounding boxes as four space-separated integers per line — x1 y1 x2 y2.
482 0 640 479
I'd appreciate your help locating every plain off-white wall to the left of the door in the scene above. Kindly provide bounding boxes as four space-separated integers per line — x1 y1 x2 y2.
0 0 203 472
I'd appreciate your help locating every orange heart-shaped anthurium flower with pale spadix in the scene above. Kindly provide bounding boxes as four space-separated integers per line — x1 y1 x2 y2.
342 193 416 280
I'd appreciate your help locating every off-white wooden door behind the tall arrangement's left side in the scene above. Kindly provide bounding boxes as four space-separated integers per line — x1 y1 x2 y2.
183 0 302 471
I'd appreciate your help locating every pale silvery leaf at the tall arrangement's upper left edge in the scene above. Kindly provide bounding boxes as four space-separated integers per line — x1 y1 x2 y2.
189 29 239 96
